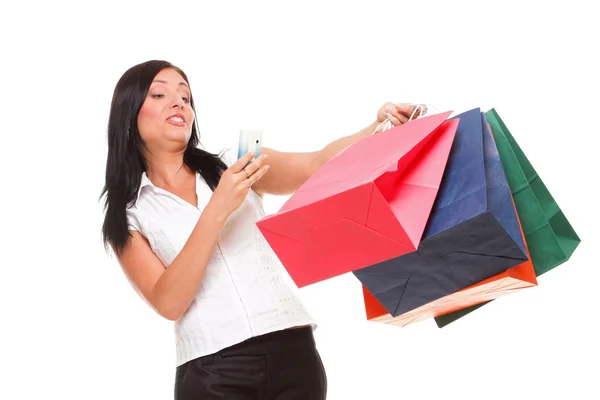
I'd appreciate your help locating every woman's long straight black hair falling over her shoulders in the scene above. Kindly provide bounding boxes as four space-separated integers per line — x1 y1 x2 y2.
100 60 227 255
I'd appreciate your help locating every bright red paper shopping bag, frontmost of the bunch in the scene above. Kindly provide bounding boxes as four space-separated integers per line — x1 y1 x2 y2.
257 112 458 287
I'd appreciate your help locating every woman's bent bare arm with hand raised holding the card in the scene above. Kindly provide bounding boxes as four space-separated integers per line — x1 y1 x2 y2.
119 155 269 321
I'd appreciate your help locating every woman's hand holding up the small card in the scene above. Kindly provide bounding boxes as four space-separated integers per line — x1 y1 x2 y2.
211 152 269 218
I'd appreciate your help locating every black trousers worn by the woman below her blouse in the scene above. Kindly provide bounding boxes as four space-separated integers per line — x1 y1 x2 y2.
175 327 327 400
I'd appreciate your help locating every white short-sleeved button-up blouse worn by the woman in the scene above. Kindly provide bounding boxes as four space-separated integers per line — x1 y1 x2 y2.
127 150 317 366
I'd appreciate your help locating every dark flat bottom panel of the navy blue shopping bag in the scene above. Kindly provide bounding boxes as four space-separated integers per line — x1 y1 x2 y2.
354 212 527 316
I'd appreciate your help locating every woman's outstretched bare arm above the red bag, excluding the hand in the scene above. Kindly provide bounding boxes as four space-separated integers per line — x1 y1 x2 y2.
252 121 379 195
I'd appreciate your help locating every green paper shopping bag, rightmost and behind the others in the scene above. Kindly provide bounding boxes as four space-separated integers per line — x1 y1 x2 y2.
435 108 581 328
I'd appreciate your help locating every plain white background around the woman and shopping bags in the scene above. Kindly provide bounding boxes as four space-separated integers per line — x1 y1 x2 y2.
0 0 600 399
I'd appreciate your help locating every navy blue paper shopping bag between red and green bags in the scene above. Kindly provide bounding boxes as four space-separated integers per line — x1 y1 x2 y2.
353 108 528 318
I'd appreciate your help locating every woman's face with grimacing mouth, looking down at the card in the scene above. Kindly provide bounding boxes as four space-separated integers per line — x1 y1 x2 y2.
137 68 195 148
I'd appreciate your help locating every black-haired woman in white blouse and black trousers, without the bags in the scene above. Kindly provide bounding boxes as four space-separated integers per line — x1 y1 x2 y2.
102 61 414 400
